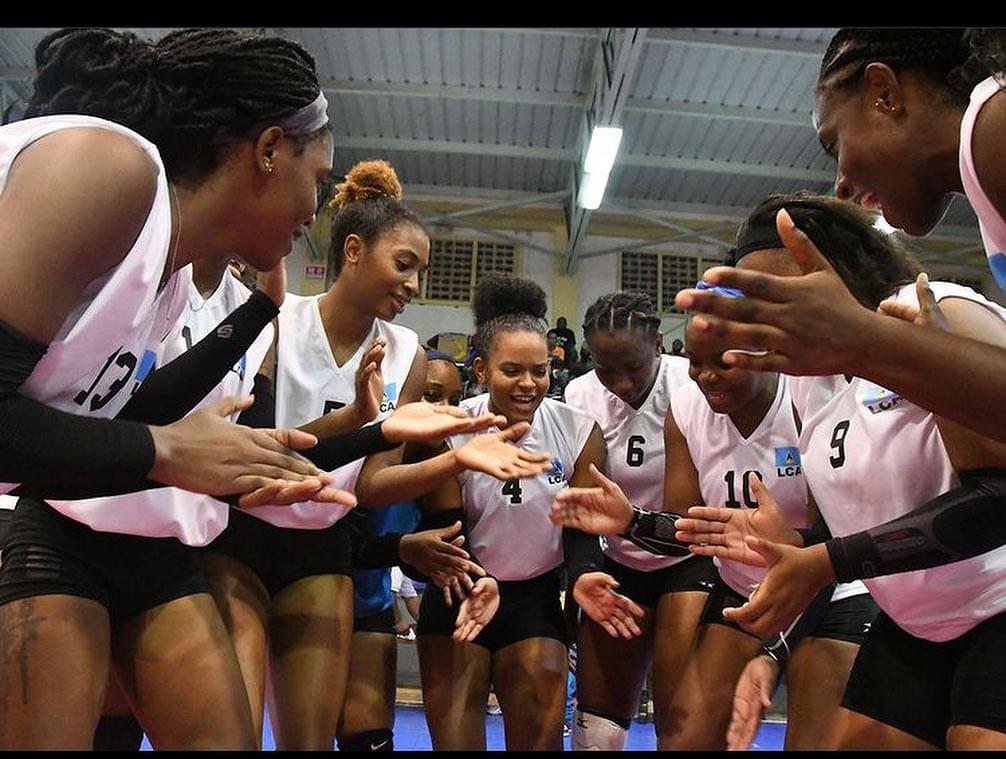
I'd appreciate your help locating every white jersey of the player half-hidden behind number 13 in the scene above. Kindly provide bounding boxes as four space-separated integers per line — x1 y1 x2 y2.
55 272 273 546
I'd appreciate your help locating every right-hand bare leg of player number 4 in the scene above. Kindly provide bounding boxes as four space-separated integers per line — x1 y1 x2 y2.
492 638 569 751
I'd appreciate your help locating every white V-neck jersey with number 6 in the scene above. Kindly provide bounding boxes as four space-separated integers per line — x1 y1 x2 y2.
565 355 691 572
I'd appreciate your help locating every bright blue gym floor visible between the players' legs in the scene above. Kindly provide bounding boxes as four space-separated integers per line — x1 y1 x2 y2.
142 706 786 751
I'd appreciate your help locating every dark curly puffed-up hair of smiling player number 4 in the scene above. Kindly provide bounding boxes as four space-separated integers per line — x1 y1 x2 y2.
472 273 548 359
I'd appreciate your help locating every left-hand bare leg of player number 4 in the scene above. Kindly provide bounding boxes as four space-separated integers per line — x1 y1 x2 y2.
418 635 490 751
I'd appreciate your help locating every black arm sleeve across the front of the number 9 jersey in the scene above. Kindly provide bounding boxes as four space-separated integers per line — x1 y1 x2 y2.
825 469 1006 583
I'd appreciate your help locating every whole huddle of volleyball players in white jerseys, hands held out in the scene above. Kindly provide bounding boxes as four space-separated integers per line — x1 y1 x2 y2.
0 23 1006 751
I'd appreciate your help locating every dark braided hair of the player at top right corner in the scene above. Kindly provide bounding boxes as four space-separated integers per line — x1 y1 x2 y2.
818 27 1006 106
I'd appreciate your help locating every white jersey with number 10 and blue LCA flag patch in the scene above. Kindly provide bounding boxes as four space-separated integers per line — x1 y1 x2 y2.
671 374 808 598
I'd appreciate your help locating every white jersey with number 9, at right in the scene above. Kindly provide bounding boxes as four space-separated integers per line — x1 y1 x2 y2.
793 282 1006 642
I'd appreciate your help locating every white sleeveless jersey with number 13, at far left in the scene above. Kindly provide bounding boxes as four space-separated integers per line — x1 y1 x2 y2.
0 116 191 535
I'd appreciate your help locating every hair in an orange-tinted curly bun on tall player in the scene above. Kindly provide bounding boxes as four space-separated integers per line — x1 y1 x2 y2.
329 161 429 276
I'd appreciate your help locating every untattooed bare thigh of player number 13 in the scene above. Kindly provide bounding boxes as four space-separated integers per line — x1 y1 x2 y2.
113 593 256 750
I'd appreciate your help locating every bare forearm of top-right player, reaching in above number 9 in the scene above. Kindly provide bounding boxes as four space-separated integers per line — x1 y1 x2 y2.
848 315 1006 442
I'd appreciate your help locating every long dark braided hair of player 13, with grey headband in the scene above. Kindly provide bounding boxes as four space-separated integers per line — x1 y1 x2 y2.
25 28 328 182
